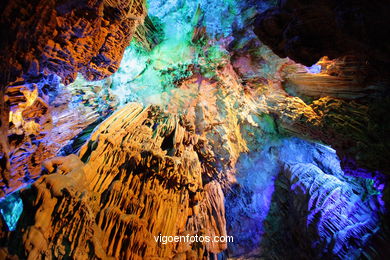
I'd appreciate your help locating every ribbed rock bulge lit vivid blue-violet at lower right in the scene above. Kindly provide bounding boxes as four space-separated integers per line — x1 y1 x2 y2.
276 163 379 259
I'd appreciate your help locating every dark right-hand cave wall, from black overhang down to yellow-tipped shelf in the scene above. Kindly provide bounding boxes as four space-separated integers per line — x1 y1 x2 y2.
253 0 390 177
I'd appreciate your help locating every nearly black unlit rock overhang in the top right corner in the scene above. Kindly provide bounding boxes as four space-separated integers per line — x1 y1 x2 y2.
254 0 390 66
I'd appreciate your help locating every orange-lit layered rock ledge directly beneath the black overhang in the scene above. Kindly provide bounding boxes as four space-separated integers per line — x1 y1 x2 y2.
283 56 386 100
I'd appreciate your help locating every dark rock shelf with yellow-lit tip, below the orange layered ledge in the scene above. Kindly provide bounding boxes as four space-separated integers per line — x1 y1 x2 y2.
268 91 390 174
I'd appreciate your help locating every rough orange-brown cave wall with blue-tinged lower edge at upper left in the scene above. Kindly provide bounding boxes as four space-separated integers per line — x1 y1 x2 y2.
0 0 146 195
